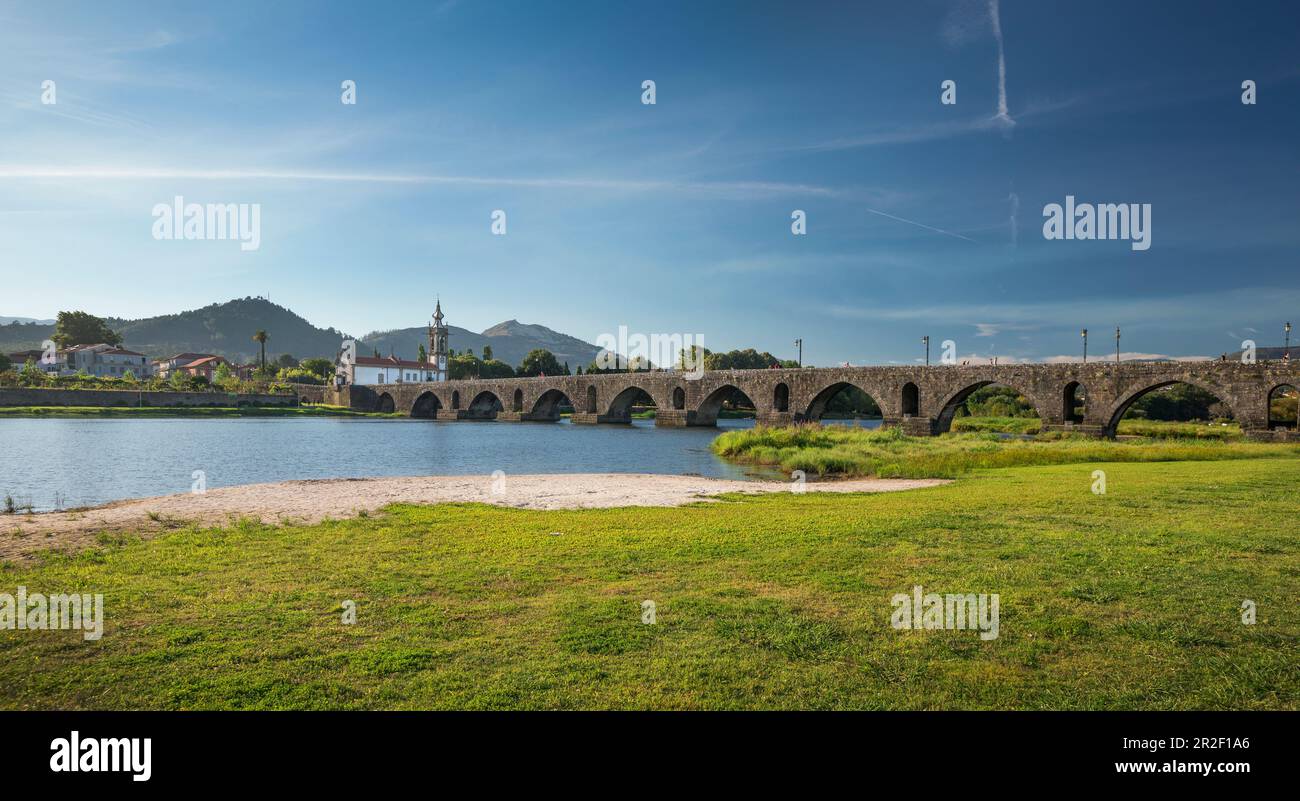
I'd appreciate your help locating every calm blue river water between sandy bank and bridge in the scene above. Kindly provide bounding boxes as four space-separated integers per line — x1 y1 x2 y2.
0 417 879 510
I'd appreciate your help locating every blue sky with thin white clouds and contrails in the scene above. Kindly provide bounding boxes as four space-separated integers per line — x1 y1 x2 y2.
0 0 1300 364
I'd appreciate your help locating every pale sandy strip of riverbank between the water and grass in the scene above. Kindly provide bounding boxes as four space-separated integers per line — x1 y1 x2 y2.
0 473 946 562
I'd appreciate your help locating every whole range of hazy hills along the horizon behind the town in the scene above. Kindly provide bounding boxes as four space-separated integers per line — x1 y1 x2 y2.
0 298 599 368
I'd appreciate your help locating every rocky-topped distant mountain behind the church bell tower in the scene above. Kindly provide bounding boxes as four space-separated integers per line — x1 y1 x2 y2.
360 320 601 369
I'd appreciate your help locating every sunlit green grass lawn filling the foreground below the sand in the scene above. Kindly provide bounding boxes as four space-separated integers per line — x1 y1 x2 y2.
0 458 1300 709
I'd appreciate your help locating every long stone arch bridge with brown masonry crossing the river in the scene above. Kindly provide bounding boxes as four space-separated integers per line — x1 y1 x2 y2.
326 361 1300 437
